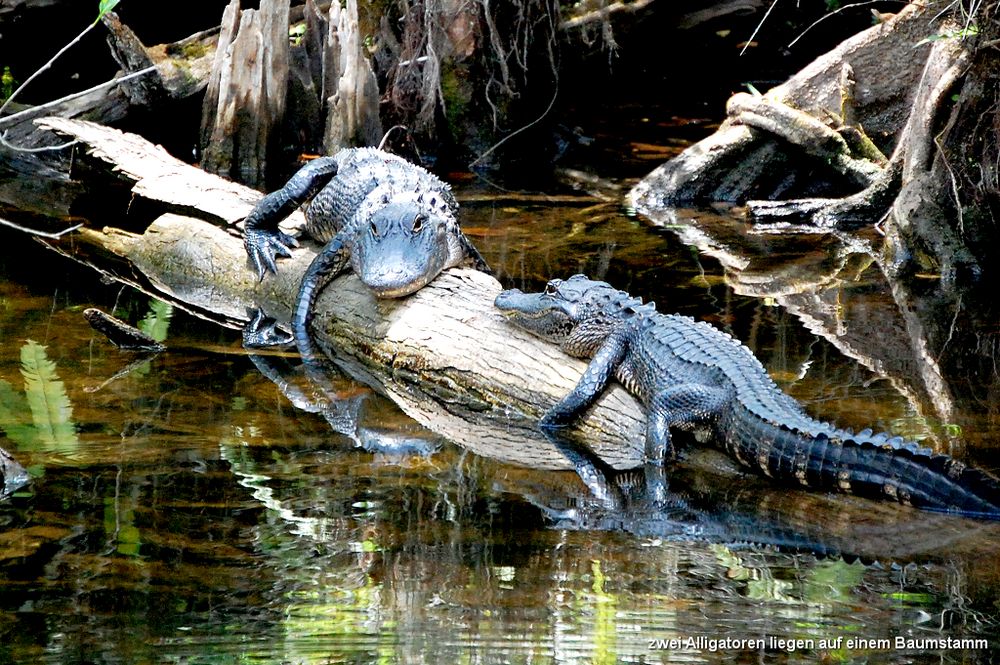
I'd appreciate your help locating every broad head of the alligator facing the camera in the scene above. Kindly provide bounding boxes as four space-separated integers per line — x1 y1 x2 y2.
351 201 457 298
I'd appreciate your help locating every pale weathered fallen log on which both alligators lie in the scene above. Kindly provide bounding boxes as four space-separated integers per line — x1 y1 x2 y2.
39 118 645 469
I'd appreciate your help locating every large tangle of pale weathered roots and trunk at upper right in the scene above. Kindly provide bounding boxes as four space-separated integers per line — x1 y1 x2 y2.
630 2 1000 285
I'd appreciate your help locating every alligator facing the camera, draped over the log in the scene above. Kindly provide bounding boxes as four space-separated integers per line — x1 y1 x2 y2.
243 148 489 341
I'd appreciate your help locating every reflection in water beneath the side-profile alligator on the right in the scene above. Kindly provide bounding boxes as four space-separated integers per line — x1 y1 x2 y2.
504 435 1000 574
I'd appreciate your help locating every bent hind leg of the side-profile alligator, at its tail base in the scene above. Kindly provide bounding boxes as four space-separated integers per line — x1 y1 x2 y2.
646 383 730 464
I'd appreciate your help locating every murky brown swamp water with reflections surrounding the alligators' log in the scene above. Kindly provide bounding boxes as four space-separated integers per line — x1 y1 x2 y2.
0 137 1000 663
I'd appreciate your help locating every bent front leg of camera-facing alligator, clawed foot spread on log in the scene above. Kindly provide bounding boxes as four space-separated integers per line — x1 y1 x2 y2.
243 157 338 281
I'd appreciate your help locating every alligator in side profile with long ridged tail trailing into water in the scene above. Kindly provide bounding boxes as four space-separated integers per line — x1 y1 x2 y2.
496 275 1000 518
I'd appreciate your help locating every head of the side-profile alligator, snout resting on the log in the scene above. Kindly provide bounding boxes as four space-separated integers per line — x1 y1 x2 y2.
494 275 642 358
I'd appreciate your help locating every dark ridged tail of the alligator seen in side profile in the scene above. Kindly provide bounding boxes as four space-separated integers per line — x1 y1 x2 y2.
724 409 1000 519
